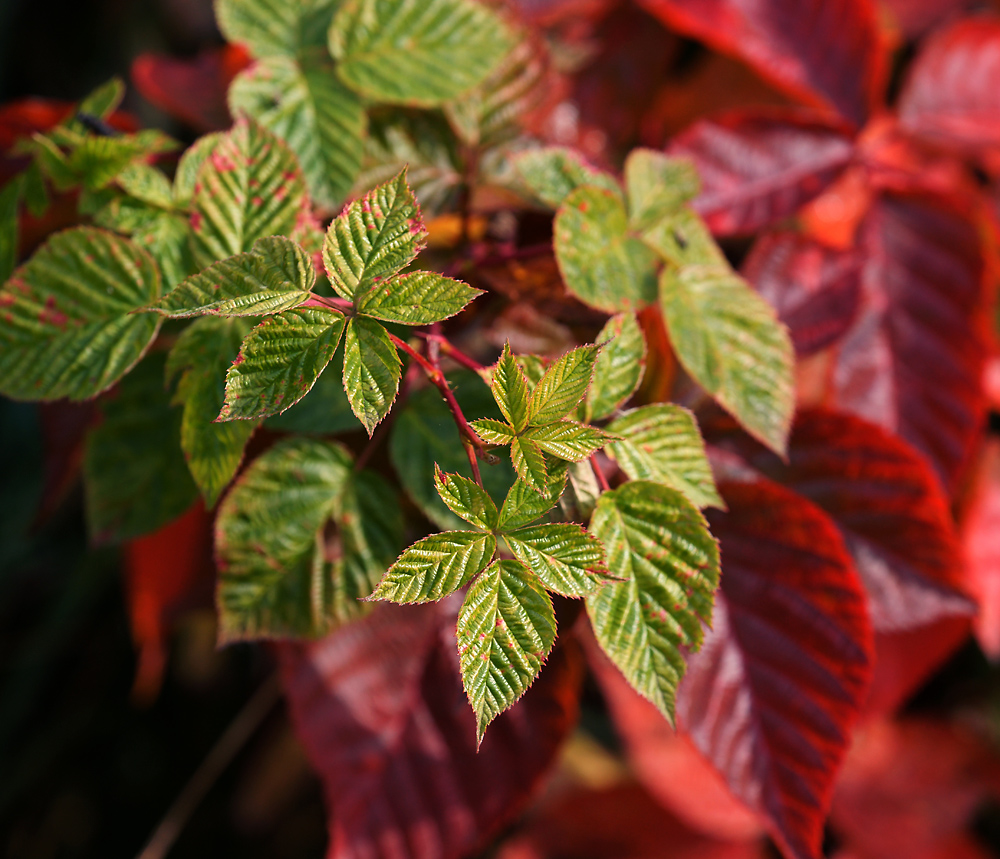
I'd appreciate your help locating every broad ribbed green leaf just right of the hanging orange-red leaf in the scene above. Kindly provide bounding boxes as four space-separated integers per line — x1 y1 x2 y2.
215 438 351 643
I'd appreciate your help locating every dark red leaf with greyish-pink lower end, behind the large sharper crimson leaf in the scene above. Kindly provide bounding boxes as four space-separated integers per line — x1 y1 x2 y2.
716 410 973 632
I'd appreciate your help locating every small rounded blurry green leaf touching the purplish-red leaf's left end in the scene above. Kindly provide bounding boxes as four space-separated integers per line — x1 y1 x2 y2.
625 149 701 230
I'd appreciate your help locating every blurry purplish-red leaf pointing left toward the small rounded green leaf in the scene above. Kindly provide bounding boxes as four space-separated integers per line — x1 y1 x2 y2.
668 108 854 235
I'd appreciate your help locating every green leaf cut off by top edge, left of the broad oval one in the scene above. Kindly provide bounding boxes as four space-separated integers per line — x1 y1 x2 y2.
215 0 340 57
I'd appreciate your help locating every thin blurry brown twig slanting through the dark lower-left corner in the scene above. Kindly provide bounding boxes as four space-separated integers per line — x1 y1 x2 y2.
137 674 281 859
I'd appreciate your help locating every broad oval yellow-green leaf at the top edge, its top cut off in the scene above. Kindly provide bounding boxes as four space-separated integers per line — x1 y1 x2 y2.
329 0 513 107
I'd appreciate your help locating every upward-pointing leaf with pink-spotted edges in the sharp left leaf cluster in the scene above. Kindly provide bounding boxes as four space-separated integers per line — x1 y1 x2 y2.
323 170 427 302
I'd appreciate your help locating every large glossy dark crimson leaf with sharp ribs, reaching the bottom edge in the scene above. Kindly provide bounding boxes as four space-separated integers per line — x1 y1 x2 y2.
677 479 872 859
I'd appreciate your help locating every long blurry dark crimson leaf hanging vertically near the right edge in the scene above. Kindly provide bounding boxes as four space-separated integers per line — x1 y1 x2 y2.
830 194 986 489
